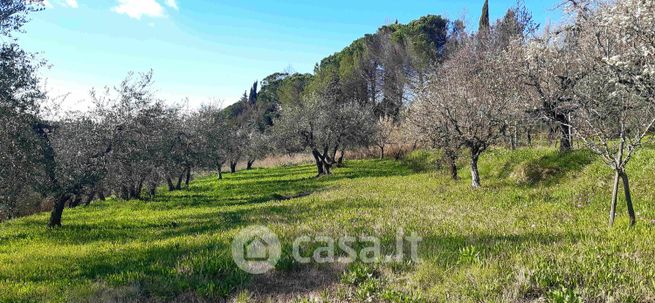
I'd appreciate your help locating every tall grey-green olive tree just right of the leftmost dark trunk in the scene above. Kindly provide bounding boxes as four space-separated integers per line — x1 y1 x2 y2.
92 72 177 199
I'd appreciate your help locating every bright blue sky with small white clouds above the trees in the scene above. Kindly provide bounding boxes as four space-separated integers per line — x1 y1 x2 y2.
19 0 561 109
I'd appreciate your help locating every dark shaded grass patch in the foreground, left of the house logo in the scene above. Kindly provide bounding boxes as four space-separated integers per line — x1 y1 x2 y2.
72 240 250 302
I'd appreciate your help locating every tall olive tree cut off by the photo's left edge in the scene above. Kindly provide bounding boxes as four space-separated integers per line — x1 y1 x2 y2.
0 0 46 218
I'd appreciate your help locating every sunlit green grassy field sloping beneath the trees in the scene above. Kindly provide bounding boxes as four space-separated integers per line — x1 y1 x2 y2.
0 149 655 302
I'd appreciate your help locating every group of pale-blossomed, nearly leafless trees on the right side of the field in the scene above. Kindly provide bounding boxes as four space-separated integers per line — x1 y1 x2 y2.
408 0 655 225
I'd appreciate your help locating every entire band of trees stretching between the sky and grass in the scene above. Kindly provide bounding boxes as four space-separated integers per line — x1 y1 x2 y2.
0 0 655 227
